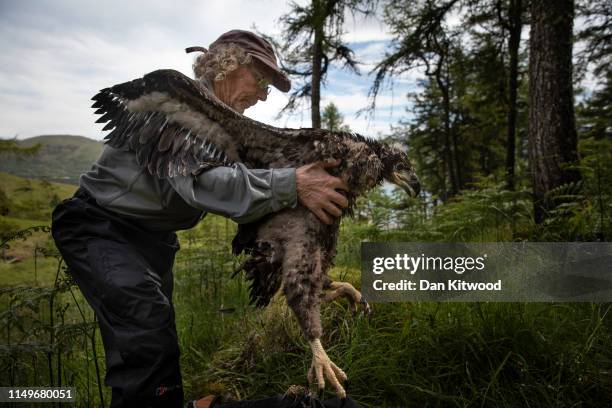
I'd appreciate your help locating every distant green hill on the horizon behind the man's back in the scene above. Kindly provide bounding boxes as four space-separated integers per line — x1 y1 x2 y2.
0 135 104 184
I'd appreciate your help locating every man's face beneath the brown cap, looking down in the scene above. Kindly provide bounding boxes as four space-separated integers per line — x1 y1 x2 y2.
215 65 268 113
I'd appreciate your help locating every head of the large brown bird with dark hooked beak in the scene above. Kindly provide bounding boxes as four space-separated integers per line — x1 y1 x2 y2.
379 145 421 197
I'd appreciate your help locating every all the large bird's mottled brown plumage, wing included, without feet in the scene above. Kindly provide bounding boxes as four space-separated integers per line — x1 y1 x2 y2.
93 70 418 396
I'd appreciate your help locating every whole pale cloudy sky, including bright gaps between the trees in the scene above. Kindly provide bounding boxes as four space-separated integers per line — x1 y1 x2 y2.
0 0 420 139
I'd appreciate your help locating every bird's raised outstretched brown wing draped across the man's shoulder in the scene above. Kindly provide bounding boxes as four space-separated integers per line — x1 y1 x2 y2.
92 70 301 178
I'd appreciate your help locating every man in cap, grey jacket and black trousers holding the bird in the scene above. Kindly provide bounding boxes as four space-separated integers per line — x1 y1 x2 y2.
52 30 348 407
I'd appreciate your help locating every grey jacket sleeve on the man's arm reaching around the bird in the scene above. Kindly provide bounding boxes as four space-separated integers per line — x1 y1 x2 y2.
168 163 297 224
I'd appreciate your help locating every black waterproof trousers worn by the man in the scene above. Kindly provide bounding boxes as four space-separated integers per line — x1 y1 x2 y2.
51 189 183 408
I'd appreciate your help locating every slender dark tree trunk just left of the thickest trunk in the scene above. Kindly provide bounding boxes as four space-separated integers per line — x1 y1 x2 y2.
506 0 523 190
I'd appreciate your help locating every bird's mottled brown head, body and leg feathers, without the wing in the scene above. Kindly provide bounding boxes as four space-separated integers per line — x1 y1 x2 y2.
232 135 418 340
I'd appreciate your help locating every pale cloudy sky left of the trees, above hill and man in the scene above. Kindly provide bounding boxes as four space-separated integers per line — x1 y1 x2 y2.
0 0 302 138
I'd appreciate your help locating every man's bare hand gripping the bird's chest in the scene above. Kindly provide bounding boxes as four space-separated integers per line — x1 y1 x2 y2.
295 160 348 225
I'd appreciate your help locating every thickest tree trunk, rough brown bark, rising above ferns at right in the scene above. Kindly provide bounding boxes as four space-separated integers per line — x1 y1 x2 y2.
529 0 580 223
